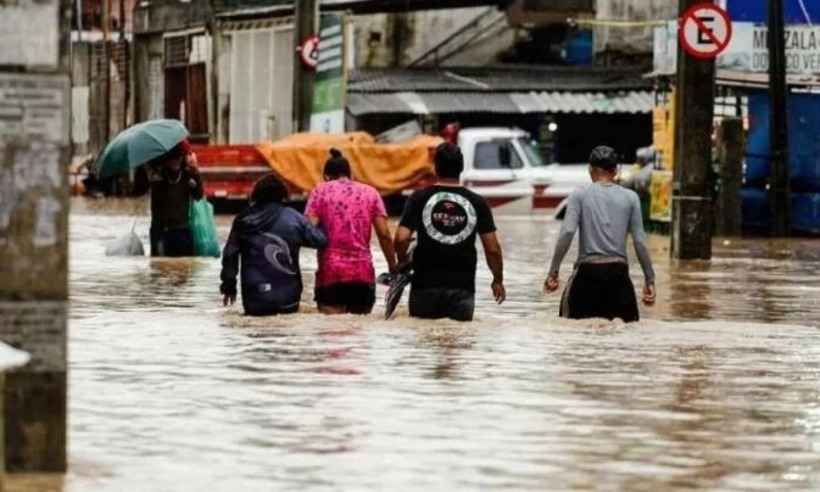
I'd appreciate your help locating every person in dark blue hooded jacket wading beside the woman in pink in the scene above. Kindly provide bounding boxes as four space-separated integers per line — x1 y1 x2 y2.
220 174 327 316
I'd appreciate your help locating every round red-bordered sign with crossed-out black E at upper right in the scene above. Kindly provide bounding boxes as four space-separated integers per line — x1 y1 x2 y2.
678 3 732 60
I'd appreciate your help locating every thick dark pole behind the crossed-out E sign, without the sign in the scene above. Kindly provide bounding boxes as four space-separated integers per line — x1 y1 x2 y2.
671 0 715 260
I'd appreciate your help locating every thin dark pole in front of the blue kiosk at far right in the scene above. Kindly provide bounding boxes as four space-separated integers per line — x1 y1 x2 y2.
767 0 791 237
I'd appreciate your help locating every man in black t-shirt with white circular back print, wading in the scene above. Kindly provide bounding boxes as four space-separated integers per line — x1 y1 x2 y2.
395 143 506 321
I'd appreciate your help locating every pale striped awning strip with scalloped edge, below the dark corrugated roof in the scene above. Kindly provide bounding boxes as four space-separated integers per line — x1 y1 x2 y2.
347 91 655 116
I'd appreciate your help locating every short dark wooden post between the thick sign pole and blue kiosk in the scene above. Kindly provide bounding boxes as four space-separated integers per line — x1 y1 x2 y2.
716 118 746 236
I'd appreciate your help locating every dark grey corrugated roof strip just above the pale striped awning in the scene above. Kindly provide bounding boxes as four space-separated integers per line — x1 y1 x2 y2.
348 66 652 93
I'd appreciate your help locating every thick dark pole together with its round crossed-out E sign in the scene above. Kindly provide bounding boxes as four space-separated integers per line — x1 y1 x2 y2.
671 0 731 260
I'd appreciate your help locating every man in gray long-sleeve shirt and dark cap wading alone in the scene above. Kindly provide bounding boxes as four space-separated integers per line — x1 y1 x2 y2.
544 146 655 322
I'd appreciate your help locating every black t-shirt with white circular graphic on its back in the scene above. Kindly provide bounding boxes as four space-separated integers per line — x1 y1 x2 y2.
401 186 495 292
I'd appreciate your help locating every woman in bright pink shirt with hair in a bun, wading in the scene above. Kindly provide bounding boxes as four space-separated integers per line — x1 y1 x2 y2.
305 149 396 314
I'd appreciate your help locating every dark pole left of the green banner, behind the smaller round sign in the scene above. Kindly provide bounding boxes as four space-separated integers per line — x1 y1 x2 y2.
293 0 319 132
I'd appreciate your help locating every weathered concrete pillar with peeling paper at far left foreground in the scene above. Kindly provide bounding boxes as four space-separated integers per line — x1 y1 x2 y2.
0 0 71 471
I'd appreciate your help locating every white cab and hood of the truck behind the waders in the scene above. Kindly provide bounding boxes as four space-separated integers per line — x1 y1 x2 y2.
458 127 590 211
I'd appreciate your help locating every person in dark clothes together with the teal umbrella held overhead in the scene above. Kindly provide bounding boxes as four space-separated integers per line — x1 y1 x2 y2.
96 120 204 256
